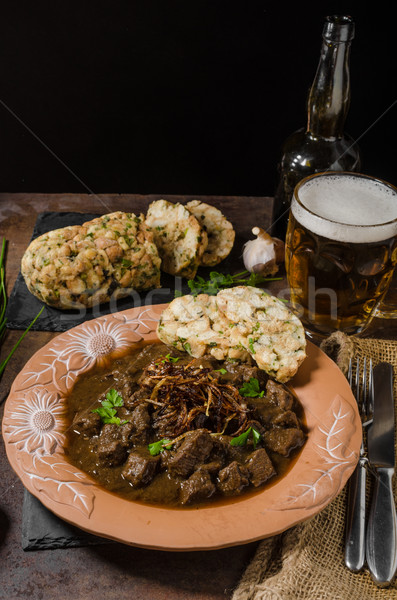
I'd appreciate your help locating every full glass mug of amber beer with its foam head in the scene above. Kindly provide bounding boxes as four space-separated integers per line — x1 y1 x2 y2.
285 171 397 341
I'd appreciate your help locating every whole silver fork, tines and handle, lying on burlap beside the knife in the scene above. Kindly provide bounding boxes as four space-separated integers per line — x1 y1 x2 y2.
345 358 373 573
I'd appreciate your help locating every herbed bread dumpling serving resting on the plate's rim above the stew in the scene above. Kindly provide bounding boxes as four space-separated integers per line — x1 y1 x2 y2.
157 286 306 383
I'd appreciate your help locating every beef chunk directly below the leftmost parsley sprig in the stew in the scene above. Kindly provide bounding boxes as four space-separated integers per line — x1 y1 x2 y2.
96 423 133 467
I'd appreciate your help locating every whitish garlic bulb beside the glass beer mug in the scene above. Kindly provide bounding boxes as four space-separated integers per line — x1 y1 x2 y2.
243 227 284 275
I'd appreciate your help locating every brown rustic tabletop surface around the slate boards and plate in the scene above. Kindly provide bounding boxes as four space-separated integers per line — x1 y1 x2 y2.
0 194 397 600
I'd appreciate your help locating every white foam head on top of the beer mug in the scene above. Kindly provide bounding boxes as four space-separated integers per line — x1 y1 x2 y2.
291 174 397 243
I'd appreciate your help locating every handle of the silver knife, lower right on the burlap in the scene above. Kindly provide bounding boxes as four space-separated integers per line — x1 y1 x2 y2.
366 467 397 586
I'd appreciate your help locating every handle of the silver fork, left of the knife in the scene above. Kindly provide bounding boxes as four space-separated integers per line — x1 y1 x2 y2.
345 458 367 573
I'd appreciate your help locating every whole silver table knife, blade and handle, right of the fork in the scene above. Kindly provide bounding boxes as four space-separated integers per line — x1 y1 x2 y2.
366 362 397 586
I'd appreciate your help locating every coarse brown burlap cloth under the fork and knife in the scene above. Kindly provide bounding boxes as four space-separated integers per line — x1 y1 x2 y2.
232 332 397 600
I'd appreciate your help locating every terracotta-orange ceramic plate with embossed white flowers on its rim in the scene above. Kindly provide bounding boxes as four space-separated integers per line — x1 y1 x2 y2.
3 304 361 550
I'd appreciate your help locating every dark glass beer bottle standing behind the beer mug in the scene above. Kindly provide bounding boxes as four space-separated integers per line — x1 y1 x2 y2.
272 15 361 239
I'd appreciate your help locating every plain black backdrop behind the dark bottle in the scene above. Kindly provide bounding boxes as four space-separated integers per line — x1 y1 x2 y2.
0 0 397 195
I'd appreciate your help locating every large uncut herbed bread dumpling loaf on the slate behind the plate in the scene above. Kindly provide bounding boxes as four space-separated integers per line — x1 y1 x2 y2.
21 211 161 309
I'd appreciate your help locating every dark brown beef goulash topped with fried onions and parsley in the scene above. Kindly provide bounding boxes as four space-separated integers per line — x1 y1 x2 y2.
66 343 306 507
